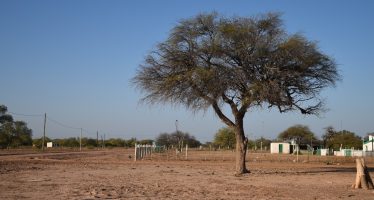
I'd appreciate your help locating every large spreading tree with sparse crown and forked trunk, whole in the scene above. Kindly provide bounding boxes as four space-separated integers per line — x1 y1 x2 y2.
133 13 339 174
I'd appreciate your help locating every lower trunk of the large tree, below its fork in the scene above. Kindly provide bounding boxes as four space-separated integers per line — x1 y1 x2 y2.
235 123 250 176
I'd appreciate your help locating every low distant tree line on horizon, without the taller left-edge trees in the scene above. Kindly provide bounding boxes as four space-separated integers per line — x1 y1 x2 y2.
29 125 368 150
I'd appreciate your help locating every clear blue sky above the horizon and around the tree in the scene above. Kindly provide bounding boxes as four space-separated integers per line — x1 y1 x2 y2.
0 0 374 142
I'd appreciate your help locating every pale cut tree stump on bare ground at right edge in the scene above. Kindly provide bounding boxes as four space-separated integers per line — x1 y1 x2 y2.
352 158 374 190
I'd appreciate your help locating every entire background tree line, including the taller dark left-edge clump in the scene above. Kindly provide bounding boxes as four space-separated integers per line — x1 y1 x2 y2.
0 105 368 150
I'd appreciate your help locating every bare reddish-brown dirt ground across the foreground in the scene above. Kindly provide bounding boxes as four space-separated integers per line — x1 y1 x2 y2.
0 149 374 199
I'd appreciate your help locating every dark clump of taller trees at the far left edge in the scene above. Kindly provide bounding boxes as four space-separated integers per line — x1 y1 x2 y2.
0 105 32 149
